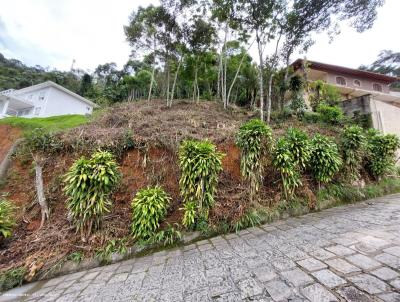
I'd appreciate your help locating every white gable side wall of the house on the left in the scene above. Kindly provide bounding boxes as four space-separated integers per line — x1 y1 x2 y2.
42 87 93 117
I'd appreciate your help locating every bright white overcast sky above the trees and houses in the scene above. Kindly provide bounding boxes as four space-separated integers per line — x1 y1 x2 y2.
0 0 400 71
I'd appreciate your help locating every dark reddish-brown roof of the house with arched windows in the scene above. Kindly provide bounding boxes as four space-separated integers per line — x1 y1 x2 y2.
292 59 400 84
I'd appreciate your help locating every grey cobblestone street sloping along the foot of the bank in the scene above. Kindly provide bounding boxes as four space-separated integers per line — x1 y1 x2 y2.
0 195 400 302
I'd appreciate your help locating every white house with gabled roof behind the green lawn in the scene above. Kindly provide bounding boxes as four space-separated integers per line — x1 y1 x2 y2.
0 81 98 118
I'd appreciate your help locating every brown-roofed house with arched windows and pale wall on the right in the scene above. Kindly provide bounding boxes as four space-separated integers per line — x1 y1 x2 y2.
292 59 400 135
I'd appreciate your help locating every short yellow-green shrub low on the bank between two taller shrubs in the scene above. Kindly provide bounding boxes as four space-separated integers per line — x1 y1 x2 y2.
131 186 171 240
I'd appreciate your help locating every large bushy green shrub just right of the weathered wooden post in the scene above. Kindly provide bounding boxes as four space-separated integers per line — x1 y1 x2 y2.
64 151 121 239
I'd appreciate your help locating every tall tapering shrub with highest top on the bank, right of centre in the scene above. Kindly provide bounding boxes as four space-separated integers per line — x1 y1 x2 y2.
236 119 272 199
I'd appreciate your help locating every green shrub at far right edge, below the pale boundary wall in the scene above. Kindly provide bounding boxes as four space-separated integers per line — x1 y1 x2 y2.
366 129 400 178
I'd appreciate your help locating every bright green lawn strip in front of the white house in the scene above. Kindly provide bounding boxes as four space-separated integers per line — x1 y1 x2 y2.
0 114 89 134
